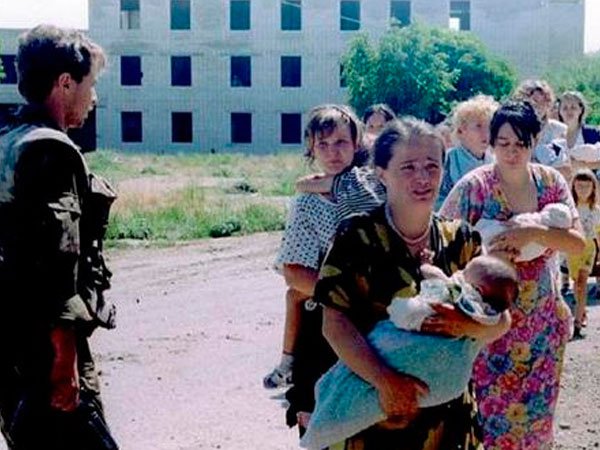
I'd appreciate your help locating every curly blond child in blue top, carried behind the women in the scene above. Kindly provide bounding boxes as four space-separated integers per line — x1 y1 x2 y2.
436 95 498 209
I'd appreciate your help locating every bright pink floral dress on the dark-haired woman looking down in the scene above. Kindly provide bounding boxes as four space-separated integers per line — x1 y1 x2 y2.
440 164 578 450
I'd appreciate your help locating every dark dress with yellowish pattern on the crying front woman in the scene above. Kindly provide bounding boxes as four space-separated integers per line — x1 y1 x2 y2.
314 206 482 450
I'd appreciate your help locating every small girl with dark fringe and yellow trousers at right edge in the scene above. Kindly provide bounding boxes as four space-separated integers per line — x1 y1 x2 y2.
567 169 600 339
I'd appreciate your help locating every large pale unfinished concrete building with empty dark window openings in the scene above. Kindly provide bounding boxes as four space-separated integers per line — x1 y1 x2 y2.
0 0 584 153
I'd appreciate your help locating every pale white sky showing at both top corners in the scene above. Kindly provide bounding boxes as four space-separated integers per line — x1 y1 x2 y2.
0 0 600 52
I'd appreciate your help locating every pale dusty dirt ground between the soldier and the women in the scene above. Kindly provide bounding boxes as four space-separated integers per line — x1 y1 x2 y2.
19 234 600 450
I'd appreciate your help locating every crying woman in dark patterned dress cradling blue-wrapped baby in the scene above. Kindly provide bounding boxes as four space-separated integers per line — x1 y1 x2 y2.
314 119 510 450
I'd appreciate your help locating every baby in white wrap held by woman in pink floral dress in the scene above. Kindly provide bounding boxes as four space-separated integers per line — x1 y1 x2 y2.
475 203 573 262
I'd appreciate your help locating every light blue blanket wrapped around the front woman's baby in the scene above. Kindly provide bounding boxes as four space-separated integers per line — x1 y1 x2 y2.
300 320 481 449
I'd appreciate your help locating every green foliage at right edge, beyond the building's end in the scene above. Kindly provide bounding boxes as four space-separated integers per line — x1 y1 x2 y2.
545 53 600 125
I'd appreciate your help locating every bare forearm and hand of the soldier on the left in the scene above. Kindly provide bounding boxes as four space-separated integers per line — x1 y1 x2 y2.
50 327 79 412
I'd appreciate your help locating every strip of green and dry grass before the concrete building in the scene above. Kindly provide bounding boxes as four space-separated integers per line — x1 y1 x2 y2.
87 150 308 245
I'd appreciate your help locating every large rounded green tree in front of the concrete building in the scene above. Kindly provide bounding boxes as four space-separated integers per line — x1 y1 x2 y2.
342 23 516 122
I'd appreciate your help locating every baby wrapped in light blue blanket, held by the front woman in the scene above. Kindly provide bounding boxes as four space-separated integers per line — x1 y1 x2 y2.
300 256 519 449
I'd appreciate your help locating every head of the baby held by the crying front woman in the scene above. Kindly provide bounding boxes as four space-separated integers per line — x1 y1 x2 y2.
462 255 519 313
